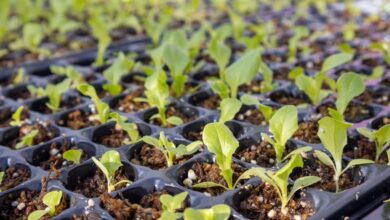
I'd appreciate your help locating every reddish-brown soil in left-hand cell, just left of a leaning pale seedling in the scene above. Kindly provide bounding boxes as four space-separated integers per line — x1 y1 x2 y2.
58 110 100 130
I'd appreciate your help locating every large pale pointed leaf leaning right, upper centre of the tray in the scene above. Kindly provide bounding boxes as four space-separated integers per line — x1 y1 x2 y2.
225 49 260 98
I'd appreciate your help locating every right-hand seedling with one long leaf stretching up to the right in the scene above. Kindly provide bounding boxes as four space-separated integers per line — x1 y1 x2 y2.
296 53 353 105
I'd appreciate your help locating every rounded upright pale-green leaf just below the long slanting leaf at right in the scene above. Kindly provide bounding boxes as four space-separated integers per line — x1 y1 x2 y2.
336 72 365 114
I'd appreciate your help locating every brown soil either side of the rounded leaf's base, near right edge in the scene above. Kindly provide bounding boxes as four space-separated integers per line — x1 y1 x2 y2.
317 103 372 123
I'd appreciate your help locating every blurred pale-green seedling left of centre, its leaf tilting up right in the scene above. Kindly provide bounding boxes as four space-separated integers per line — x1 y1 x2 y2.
103 52 135 96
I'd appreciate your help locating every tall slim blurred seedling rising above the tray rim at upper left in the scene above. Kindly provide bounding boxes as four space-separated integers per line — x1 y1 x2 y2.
88 14 111 66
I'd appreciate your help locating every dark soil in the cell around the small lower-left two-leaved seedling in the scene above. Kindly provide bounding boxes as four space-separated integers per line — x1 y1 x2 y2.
72 167 129 198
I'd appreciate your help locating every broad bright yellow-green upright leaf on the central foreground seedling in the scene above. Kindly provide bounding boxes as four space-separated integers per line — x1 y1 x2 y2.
203 122 239 188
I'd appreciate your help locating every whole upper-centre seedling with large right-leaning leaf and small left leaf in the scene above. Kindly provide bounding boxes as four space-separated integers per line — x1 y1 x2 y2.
209 49 260 98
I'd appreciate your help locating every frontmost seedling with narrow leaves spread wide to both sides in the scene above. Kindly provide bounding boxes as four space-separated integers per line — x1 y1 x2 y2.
240 154 321 208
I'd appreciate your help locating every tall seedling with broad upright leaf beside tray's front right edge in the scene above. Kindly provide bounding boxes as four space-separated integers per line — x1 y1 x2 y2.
314 117 373 192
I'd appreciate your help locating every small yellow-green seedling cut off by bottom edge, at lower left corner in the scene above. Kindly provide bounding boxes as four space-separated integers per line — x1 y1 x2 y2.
28 191 62 220
